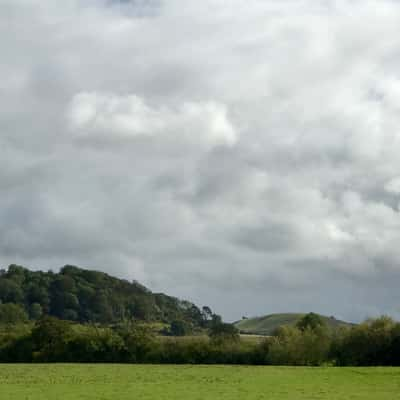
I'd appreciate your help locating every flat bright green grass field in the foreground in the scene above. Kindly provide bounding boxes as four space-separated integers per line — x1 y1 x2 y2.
0 364 400 400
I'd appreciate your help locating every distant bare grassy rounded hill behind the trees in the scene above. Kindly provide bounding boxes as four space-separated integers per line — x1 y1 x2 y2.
234 313 353 336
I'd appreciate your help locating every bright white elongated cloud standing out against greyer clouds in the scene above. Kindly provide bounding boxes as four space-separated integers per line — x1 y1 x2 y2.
68 93 237 147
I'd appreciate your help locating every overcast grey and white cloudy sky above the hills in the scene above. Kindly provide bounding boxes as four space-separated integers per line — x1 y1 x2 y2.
0 0 400 321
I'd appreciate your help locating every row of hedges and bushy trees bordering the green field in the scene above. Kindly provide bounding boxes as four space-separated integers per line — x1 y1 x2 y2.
0 313 400 366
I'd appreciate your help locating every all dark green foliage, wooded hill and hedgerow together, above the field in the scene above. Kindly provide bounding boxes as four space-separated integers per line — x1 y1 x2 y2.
0 265 400 366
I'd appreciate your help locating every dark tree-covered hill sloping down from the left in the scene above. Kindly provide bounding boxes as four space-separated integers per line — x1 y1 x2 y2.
0 265 211 327
